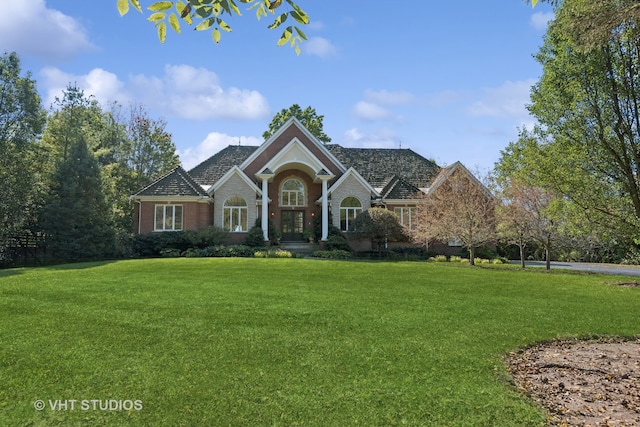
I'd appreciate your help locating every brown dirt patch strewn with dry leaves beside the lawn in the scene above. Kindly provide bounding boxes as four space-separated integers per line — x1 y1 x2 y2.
506 339 640 427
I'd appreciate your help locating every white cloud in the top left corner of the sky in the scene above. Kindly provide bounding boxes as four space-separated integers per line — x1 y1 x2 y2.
0 0 96 61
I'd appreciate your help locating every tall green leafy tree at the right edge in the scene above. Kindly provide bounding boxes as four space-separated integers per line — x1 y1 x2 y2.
520 0 640 244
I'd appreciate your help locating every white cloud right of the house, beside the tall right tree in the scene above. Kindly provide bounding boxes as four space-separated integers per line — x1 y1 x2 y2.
467 79 536 120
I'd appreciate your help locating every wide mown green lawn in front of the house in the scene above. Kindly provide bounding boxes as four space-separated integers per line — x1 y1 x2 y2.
0 258 640 426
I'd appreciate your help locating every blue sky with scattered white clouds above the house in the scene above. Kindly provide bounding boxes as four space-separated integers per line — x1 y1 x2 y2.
0 0 553 172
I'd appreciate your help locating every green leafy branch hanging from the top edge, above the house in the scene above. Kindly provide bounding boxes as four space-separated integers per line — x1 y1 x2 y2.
117 0 309 55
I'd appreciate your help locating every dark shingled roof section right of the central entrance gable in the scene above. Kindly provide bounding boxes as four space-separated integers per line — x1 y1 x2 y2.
325 144 440 188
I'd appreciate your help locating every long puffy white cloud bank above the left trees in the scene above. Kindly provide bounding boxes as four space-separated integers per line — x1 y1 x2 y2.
41 65 270 120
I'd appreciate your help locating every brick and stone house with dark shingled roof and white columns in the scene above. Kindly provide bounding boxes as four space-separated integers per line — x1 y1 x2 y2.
132 118 476 249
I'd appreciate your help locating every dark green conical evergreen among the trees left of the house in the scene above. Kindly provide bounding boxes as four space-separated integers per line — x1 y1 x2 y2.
42 139 115 260
